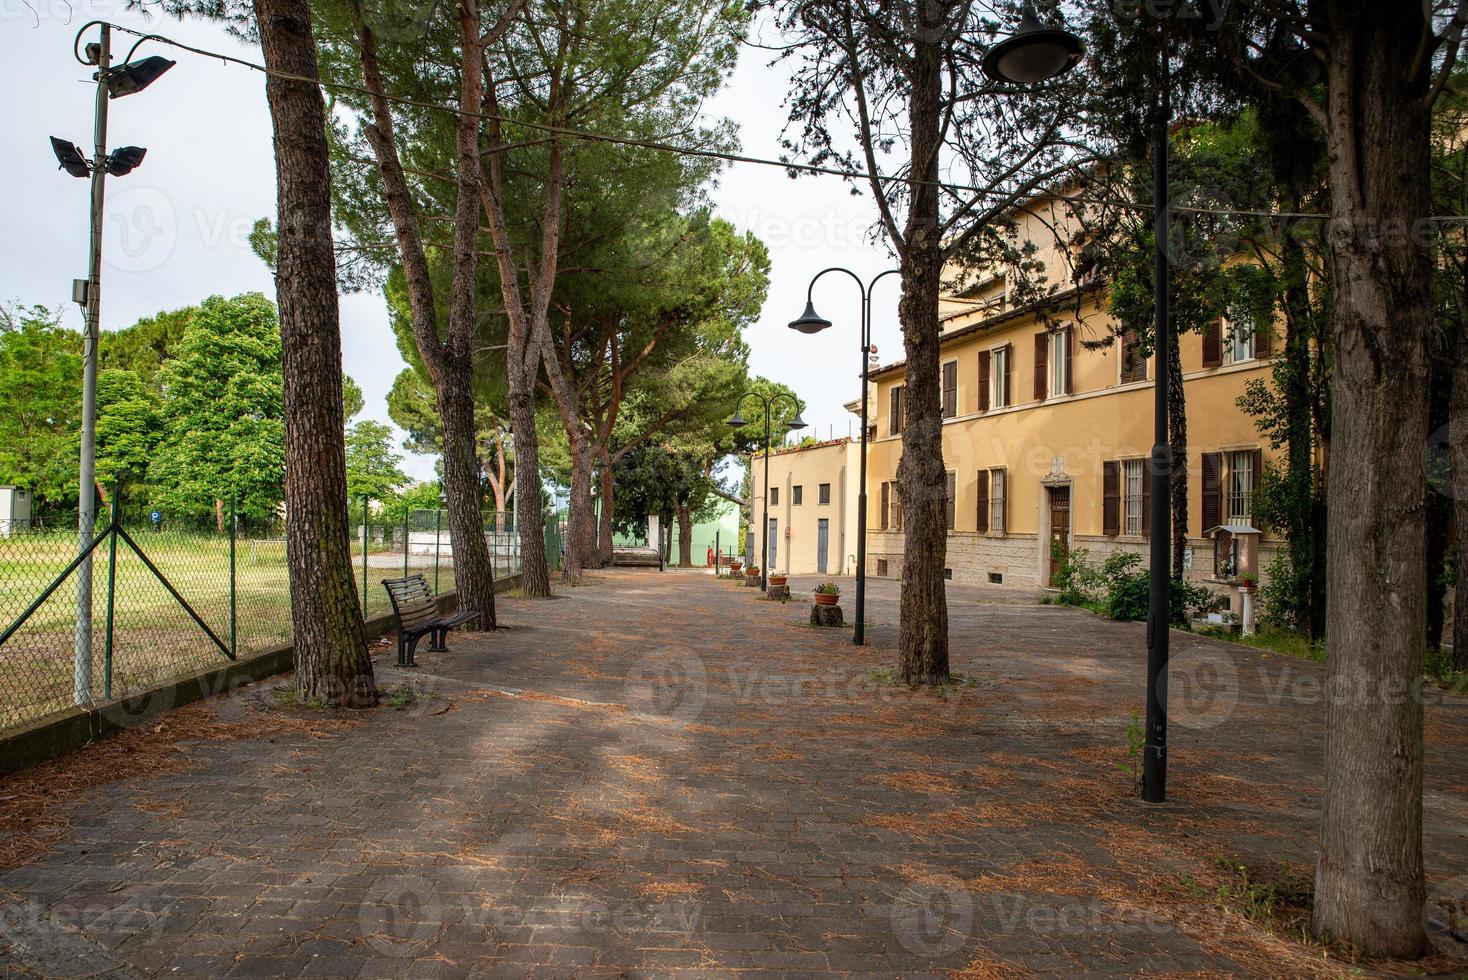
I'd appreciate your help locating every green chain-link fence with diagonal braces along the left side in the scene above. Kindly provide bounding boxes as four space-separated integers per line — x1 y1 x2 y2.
0 500 562 731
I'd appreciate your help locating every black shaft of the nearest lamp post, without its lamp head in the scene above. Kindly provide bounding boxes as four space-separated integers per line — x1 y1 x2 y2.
1142 57 1173 802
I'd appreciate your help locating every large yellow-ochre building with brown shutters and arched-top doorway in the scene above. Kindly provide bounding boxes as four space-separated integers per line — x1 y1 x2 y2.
806 190 1279 587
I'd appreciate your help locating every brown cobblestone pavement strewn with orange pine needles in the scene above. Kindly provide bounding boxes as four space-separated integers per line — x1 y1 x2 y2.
0 571 1468 977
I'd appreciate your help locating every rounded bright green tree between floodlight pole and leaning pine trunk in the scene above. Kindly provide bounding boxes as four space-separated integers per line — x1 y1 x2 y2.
151 293 285 530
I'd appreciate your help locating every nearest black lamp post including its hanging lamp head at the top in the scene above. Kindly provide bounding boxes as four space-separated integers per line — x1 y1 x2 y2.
984 3 1173 802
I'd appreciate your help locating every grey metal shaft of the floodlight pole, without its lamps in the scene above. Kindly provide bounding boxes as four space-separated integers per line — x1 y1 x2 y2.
72 23 112 704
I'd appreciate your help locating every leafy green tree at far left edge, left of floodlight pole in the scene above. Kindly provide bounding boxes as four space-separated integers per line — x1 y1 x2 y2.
0 307 82 513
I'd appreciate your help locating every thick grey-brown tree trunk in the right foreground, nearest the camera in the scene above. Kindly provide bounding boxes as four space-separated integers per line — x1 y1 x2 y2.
1314 3 1433 957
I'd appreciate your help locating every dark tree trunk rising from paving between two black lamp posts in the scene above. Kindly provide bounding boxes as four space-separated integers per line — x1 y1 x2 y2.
897 4 948 684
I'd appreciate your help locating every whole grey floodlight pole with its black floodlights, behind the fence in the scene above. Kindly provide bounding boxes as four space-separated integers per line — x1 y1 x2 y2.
51 21 173 704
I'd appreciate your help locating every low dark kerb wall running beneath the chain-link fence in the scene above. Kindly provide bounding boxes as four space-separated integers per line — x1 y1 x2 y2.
0 575 520 776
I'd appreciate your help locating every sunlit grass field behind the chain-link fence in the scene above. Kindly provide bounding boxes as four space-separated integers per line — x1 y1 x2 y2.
0 530 525 729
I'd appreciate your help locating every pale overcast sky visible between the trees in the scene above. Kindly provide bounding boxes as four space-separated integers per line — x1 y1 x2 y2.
0 0 901 478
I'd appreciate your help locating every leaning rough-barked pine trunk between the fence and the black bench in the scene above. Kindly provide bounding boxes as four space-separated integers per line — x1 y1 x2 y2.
254 0 377 707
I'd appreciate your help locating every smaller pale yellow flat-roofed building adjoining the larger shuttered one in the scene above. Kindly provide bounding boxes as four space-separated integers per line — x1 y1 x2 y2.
753 439 860 577
